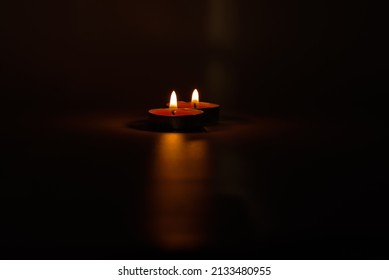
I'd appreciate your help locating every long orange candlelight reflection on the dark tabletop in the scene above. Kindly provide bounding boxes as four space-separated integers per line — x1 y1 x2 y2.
147 133 210 250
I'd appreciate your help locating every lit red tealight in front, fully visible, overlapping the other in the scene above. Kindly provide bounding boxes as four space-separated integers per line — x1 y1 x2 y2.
149 91 204 130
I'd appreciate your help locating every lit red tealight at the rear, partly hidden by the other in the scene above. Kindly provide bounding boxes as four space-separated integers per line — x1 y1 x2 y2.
168 89 220 124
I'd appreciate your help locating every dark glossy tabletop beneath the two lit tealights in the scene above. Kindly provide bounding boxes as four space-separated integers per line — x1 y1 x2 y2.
0 107 389 259
